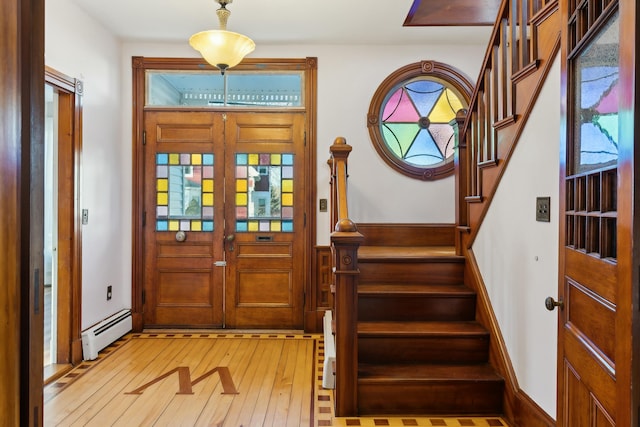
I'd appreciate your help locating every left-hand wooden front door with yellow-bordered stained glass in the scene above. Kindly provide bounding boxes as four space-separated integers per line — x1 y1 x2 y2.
144 112 225 327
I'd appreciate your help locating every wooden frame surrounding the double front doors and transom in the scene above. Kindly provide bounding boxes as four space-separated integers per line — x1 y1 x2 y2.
131 57 320 331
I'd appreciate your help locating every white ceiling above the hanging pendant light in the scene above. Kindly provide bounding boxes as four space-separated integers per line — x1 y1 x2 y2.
73 0 491 45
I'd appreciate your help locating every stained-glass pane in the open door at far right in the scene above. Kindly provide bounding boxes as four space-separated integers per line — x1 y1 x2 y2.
574 16 620 174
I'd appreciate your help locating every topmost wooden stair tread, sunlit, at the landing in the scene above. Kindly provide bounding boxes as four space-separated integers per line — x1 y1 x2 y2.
358 246 464 262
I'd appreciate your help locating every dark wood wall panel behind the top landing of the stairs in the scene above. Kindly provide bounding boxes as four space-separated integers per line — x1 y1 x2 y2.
358 223 456 246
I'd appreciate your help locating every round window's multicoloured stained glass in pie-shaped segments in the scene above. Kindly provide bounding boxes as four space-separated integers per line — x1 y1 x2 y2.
380 76 465 167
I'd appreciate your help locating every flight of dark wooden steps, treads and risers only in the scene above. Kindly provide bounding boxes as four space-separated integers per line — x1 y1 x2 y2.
357 243 504 415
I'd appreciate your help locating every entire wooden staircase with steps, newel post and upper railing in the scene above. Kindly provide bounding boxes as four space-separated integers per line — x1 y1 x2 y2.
329 0 560 420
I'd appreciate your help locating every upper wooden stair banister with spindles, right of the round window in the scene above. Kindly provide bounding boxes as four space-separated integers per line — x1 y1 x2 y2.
457 0 558 234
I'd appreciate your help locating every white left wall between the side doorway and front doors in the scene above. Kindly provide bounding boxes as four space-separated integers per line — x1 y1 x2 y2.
45 0 131 329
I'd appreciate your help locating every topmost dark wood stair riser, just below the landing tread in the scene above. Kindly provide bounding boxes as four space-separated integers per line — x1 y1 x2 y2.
358 263 464 285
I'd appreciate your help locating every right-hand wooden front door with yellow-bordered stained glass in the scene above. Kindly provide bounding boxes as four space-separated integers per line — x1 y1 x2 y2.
225 113 306 328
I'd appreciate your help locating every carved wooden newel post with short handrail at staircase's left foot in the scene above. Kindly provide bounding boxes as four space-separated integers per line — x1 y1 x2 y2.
329 137 364 416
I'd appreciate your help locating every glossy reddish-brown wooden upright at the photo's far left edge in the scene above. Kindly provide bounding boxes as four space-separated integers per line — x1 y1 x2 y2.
0 0 29 426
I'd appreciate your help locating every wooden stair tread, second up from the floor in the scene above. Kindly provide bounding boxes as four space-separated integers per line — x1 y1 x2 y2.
358 321 488 337
